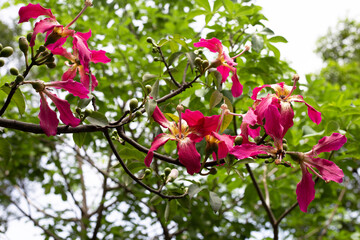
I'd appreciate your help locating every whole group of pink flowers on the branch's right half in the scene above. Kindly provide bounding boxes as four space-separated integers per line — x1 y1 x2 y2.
145 38 347 212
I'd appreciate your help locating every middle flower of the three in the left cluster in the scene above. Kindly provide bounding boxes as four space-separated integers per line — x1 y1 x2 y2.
51 33 111 90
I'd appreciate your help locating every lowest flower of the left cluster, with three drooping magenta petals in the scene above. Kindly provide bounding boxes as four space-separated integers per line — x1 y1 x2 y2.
32 80 89 136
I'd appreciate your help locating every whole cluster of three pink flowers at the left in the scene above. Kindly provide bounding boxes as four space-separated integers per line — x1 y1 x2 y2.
19 1 111 136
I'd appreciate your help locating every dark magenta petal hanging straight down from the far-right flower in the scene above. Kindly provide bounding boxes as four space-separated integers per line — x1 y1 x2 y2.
296 165 315 212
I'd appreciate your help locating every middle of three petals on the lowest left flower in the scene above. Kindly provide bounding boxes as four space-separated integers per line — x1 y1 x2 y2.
44 89 80 127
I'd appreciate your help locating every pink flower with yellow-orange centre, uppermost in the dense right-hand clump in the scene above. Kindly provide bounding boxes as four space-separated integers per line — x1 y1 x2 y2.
251 79 321 135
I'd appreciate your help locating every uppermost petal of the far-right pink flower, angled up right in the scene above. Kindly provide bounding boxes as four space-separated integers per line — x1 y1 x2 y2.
312 133 347 154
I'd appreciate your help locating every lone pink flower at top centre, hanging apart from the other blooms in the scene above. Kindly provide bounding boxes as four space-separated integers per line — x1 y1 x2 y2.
194 38 249 97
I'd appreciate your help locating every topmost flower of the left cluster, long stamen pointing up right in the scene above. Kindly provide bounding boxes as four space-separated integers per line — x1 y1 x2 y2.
18 0 92 50
